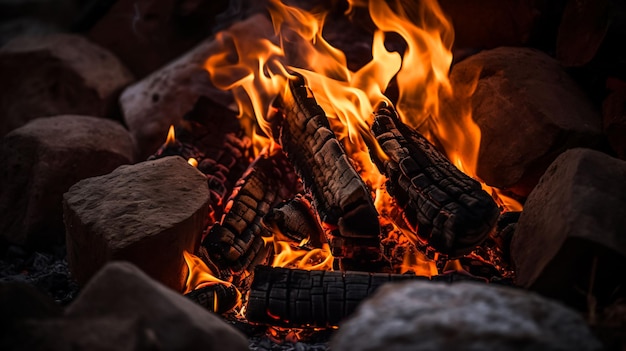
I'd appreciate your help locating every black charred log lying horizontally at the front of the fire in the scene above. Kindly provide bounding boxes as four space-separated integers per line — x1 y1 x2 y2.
246 266 484 328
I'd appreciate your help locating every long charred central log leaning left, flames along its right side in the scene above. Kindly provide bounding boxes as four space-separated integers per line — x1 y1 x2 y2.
270 76 380 258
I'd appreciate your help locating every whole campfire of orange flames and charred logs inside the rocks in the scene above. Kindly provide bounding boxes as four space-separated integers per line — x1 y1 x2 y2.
144 1 521 327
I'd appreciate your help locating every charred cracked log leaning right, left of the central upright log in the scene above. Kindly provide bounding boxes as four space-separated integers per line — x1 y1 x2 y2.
202 149 301 284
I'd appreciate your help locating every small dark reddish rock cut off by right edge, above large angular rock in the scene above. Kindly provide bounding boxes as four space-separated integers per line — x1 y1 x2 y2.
602 88 626 160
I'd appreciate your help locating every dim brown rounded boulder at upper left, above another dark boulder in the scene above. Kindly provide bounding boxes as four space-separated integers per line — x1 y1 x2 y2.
0 34 132 136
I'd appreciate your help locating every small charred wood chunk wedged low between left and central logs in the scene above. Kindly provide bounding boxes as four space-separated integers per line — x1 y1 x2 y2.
263 195 326 249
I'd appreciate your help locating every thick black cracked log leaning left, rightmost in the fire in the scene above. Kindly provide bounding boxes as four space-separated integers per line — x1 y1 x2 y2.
372 104 499 256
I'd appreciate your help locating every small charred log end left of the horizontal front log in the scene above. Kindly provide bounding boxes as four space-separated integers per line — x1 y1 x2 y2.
185 284 239 314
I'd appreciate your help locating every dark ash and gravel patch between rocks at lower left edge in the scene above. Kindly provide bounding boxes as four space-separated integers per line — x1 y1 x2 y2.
0 245 78 306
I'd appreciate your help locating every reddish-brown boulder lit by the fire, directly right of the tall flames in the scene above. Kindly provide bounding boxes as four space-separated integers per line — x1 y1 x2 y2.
444 47 602 197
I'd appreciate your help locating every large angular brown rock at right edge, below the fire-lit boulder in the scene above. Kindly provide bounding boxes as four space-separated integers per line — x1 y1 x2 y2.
511 149 626 310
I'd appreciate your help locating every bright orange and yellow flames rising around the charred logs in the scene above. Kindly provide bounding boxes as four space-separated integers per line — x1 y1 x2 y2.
201 0 521 276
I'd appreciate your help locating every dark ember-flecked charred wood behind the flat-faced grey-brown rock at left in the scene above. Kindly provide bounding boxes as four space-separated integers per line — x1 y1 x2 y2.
149 97 252 225
